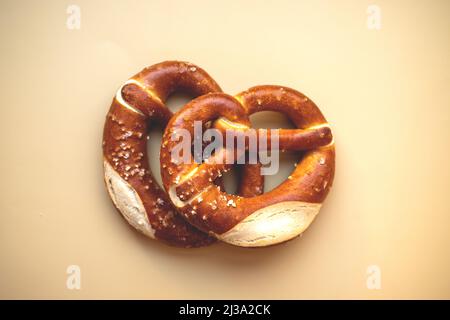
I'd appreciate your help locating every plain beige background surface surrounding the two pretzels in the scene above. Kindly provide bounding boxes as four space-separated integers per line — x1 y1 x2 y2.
0 0 450 299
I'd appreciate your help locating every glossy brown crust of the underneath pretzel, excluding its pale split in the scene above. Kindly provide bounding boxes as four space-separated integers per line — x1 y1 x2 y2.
103 61 260 247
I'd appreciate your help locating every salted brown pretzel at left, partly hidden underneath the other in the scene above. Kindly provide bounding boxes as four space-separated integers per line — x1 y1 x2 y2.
103 61 263 247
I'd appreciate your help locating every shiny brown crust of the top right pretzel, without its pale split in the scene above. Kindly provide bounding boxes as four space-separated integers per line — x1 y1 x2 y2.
160 86 335 235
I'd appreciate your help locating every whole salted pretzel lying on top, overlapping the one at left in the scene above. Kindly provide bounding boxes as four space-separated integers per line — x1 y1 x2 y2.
160 86 335 247
